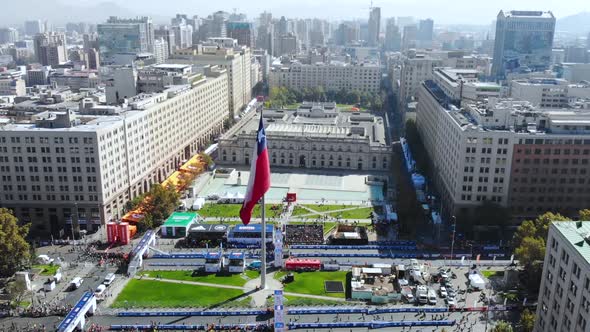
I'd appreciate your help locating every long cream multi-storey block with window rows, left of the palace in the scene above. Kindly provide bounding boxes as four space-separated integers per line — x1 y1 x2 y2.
0 70 229 236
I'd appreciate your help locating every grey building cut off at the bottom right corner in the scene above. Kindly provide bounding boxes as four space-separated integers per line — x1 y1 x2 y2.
534 221 590 332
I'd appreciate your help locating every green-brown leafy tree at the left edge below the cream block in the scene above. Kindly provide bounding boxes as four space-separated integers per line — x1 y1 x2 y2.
0 208 30 277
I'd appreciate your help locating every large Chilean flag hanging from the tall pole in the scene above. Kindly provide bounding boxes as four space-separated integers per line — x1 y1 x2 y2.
240 113 270 225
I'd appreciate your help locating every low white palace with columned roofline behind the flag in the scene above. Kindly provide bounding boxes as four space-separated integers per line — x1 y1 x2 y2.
217 102 392 171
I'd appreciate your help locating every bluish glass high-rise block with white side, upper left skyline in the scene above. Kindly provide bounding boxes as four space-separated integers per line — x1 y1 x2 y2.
97 16 154 61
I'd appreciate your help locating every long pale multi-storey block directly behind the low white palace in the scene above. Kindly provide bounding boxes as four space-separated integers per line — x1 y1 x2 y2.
269 61 381 93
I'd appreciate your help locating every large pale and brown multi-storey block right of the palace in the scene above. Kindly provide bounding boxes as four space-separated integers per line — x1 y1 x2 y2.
416 80 590 219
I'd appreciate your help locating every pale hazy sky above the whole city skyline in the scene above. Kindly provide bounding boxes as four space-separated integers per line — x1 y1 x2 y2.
0 0 590 26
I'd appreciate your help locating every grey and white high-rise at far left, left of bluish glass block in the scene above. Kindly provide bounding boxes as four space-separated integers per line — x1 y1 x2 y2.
34 32 68 67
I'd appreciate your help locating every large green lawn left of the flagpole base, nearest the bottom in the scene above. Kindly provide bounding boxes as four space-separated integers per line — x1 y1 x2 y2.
112 279 243 308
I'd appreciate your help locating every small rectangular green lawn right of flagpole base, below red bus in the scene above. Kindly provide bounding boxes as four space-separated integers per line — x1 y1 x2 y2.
275 271 346 298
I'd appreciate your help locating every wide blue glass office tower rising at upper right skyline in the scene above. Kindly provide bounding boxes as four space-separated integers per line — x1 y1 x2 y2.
492 10 555 79
